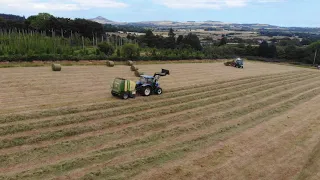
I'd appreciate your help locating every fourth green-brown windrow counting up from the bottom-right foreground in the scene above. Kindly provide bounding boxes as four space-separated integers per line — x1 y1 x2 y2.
0 72 316 149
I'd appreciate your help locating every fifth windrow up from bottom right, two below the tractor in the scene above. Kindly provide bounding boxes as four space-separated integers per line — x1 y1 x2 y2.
0 71 312 136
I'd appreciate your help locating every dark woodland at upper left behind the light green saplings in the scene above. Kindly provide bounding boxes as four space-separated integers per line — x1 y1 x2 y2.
0 13 145 39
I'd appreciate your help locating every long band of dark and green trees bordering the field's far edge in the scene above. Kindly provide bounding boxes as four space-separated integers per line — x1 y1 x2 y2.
0 13 319 64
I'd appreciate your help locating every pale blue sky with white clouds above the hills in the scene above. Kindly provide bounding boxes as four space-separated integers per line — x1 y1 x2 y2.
0 0 320 27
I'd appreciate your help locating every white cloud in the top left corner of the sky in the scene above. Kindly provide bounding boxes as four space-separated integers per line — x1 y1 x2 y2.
0 0 128 11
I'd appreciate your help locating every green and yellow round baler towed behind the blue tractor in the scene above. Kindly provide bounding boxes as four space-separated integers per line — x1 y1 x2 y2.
111 78 136 99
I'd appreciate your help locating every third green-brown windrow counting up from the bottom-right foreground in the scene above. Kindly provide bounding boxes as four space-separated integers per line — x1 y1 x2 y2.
0 74 313 167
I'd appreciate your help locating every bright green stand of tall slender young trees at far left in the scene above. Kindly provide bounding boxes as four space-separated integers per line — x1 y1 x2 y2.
0 30 106 61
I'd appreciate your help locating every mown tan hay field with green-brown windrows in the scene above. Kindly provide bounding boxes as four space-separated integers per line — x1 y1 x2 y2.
0 62 320 180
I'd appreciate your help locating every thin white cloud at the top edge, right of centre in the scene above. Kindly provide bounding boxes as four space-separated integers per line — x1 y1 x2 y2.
154 0 284 9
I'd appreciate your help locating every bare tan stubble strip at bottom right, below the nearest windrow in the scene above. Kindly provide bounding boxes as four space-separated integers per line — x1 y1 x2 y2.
138 96 320 179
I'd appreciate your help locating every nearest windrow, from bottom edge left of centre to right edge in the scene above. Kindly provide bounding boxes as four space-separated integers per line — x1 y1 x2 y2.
56 88 320 178
